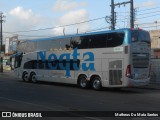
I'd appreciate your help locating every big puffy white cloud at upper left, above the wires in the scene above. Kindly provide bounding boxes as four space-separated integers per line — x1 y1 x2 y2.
6 6 47 31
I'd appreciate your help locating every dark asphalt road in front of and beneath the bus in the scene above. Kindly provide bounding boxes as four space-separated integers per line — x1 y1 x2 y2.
0 71 160 120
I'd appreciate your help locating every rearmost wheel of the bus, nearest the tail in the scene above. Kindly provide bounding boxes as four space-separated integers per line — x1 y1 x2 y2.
91 77 102 91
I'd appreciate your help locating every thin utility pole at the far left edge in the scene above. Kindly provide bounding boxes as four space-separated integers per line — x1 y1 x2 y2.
0 12 5 72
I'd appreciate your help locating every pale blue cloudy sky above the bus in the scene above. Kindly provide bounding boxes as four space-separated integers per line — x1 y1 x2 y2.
0 0 160 39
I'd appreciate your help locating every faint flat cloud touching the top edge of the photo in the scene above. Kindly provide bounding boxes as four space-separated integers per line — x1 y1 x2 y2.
53 0 87 11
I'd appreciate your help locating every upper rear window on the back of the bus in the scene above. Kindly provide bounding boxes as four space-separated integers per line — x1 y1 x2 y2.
131 30 150 44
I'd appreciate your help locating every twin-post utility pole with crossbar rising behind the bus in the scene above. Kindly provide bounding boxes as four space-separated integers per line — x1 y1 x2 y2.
110 0 134 30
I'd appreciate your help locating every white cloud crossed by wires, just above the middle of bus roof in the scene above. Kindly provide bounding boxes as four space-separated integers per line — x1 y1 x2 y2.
53 9 89 35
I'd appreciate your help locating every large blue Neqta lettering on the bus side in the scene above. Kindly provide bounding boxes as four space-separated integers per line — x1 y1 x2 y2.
37 48 95 77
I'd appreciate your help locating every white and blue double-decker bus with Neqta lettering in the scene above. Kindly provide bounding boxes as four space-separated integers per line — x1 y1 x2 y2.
12 28 151 90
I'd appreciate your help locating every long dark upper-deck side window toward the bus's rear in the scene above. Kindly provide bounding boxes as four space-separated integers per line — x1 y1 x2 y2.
70 33 125 49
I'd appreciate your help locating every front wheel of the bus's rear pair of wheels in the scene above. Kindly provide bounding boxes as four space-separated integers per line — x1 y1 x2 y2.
78 75 89 89
